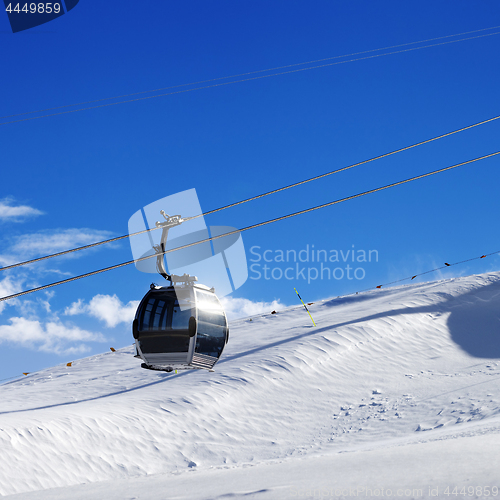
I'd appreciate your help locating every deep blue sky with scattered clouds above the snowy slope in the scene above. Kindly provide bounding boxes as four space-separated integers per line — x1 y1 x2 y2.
0 0 500 379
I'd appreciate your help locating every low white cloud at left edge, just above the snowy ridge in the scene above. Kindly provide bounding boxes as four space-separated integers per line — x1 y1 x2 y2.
0 317 105 354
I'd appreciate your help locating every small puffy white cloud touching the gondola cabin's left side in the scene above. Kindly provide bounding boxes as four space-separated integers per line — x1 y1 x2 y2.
64 295 139 328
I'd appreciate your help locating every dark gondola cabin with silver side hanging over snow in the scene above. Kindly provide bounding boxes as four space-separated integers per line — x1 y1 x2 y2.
132 275 229 372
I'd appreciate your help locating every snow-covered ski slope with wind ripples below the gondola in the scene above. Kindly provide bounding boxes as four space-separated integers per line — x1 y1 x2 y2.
0 272 500 500
